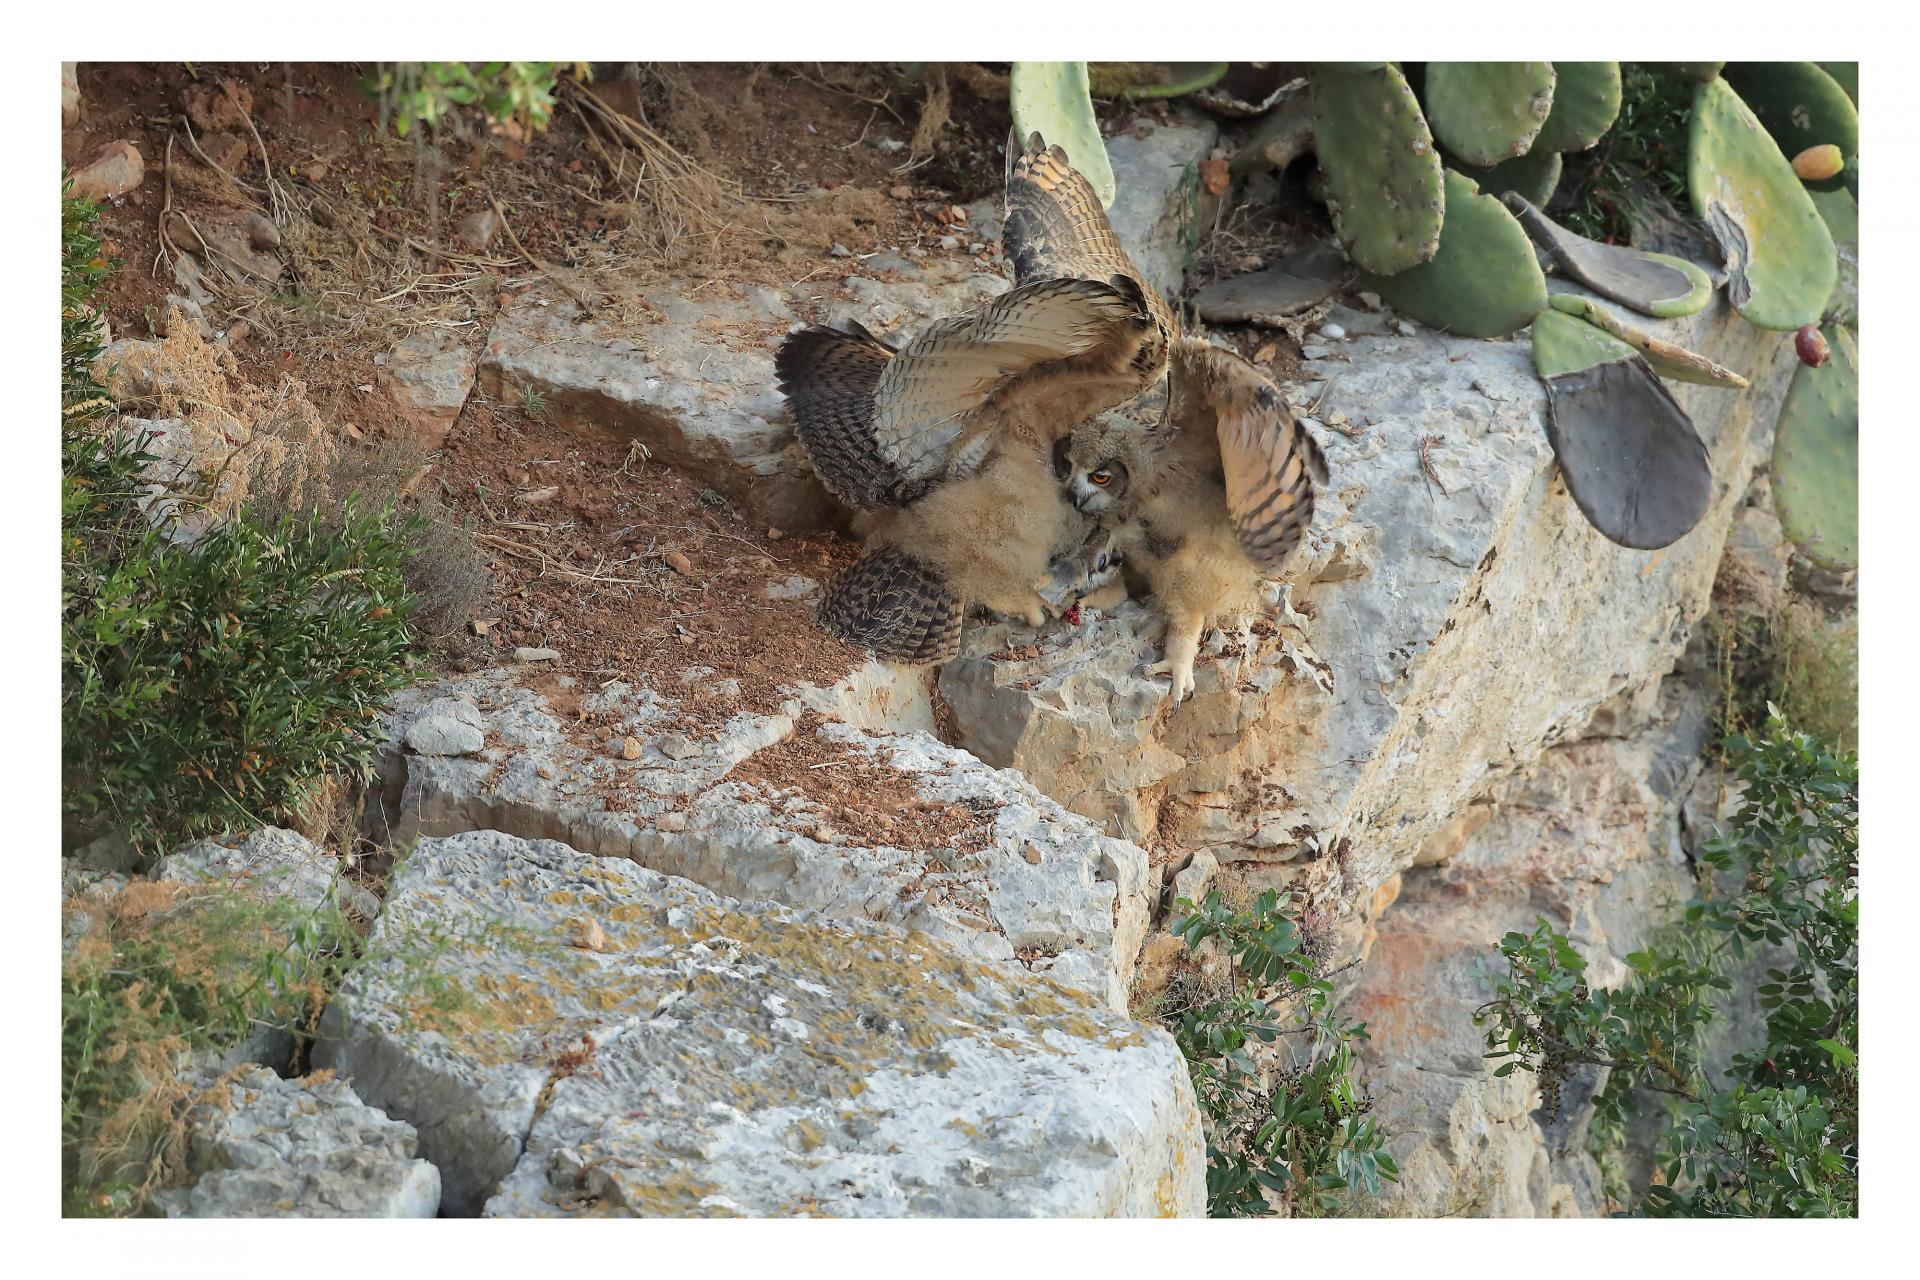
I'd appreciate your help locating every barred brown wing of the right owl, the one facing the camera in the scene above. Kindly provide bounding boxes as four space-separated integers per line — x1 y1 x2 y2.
1171 338 1327 574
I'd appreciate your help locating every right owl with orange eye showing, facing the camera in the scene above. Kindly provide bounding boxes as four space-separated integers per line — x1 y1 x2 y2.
1056 338 1327 706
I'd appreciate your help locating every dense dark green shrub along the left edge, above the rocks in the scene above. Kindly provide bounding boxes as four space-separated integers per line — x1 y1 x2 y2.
60 189 413 846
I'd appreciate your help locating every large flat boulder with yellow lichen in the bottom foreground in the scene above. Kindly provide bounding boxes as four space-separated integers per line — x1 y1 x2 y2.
317 831 1206 1217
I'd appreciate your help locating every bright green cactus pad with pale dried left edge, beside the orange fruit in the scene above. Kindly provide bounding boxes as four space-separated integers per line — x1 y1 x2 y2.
1686 81 1837 332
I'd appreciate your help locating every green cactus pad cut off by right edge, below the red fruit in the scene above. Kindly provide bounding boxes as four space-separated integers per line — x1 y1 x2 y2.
1772 326 1860 570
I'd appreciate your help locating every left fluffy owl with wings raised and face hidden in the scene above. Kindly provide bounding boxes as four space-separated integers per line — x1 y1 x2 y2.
774 134 1173 662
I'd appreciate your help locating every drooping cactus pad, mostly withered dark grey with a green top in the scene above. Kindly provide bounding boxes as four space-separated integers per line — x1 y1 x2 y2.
1534 309 1713 551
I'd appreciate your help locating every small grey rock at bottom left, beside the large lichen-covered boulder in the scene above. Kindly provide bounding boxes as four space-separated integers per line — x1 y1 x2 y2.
154 1067 440 1219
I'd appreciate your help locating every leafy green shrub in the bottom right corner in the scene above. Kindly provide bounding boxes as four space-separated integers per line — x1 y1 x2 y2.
1475 710 1860 1217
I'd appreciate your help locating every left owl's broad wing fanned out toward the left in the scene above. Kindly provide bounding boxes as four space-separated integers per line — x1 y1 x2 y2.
774 280 1142 510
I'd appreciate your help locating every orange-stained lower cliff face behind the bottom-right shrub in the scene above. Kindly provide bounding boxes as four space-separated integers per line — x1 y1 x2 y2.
1344 677 1711 1217
